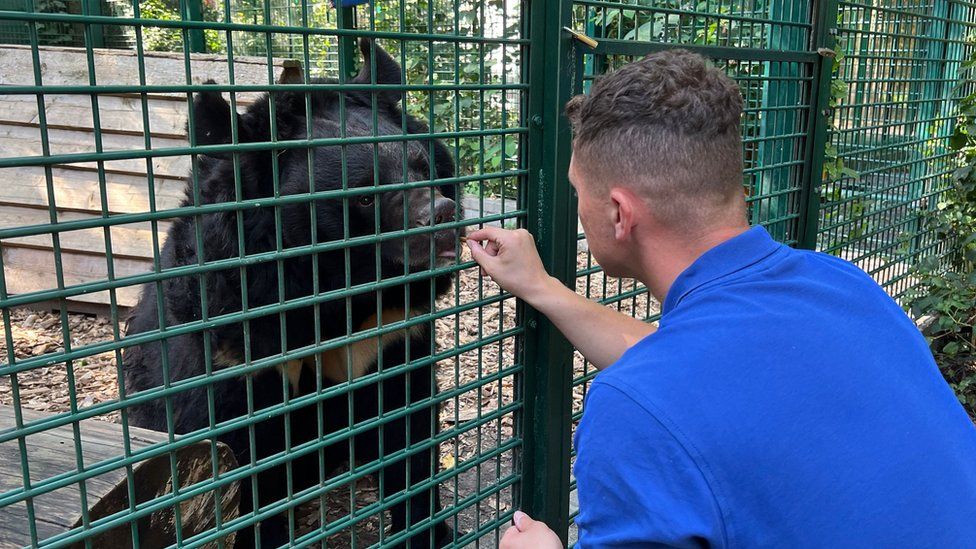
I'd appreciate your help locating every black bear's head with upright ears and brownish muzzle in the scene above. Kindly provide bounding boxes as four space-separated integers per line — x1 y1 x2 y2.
193 39 460 270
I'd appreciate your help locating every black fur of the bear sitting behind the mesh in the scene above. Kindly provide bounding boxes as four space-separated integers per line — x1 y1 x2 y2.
123 40 457 547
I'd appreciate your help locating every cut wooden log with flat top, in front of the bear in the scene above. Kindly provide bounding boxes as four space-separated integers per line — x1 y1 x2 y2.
0 406 240 549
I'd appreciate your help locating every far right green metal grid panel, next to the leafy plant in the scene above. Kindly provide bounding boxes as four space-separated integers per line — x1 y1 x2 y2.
817 0 976 297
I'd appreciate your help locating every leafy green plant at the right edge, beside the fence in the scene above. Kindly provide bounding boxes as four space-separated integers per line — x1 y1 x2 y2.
908 51 976 410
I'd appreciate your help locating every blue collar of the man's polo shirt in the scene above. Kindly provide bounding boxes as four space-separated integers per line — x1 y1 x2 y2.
661 225 783 314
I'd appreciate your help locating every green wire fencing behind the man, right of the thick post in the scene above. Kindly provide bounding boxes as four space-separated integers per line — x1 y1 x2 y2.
551 0 976 541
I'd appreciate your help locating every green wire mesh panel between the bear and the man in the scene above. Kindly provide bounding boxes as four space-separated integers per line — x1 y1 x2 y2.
0 0 527 547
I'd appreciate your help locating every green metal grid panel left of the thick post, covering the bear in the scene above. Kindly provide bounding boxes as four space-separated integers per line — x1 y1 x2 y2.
0 0 538 547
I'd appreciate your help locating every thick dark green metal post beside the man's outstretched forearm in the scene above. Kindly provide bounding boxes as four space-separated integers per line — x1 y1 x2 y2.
520 0 577 543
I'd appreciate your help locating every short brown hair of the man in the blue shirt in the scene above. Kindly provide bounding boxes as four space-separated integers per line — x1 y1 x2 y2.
566 49 743 226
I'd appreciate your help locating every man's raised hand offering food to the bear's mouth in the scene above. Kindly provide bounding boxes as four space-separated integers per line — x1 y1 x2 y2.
468 227 558 303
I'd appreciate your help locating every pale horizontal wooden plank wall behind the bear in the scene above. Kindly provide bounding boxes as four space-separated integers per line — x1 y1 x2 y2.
0 45 283 311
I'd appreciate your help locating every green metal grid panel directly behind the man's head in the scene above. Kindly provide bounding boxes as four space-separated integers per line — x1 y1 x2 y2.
559 0 825 541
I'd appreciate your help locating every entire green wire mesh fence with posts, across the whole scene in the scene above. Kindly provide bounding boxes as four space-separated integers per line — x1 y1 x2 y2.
0 0 976 547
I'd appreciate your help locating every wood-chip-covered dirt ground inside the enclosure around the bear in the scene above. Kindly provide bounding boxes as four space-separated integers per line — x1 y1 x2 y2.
0 251 657 547
